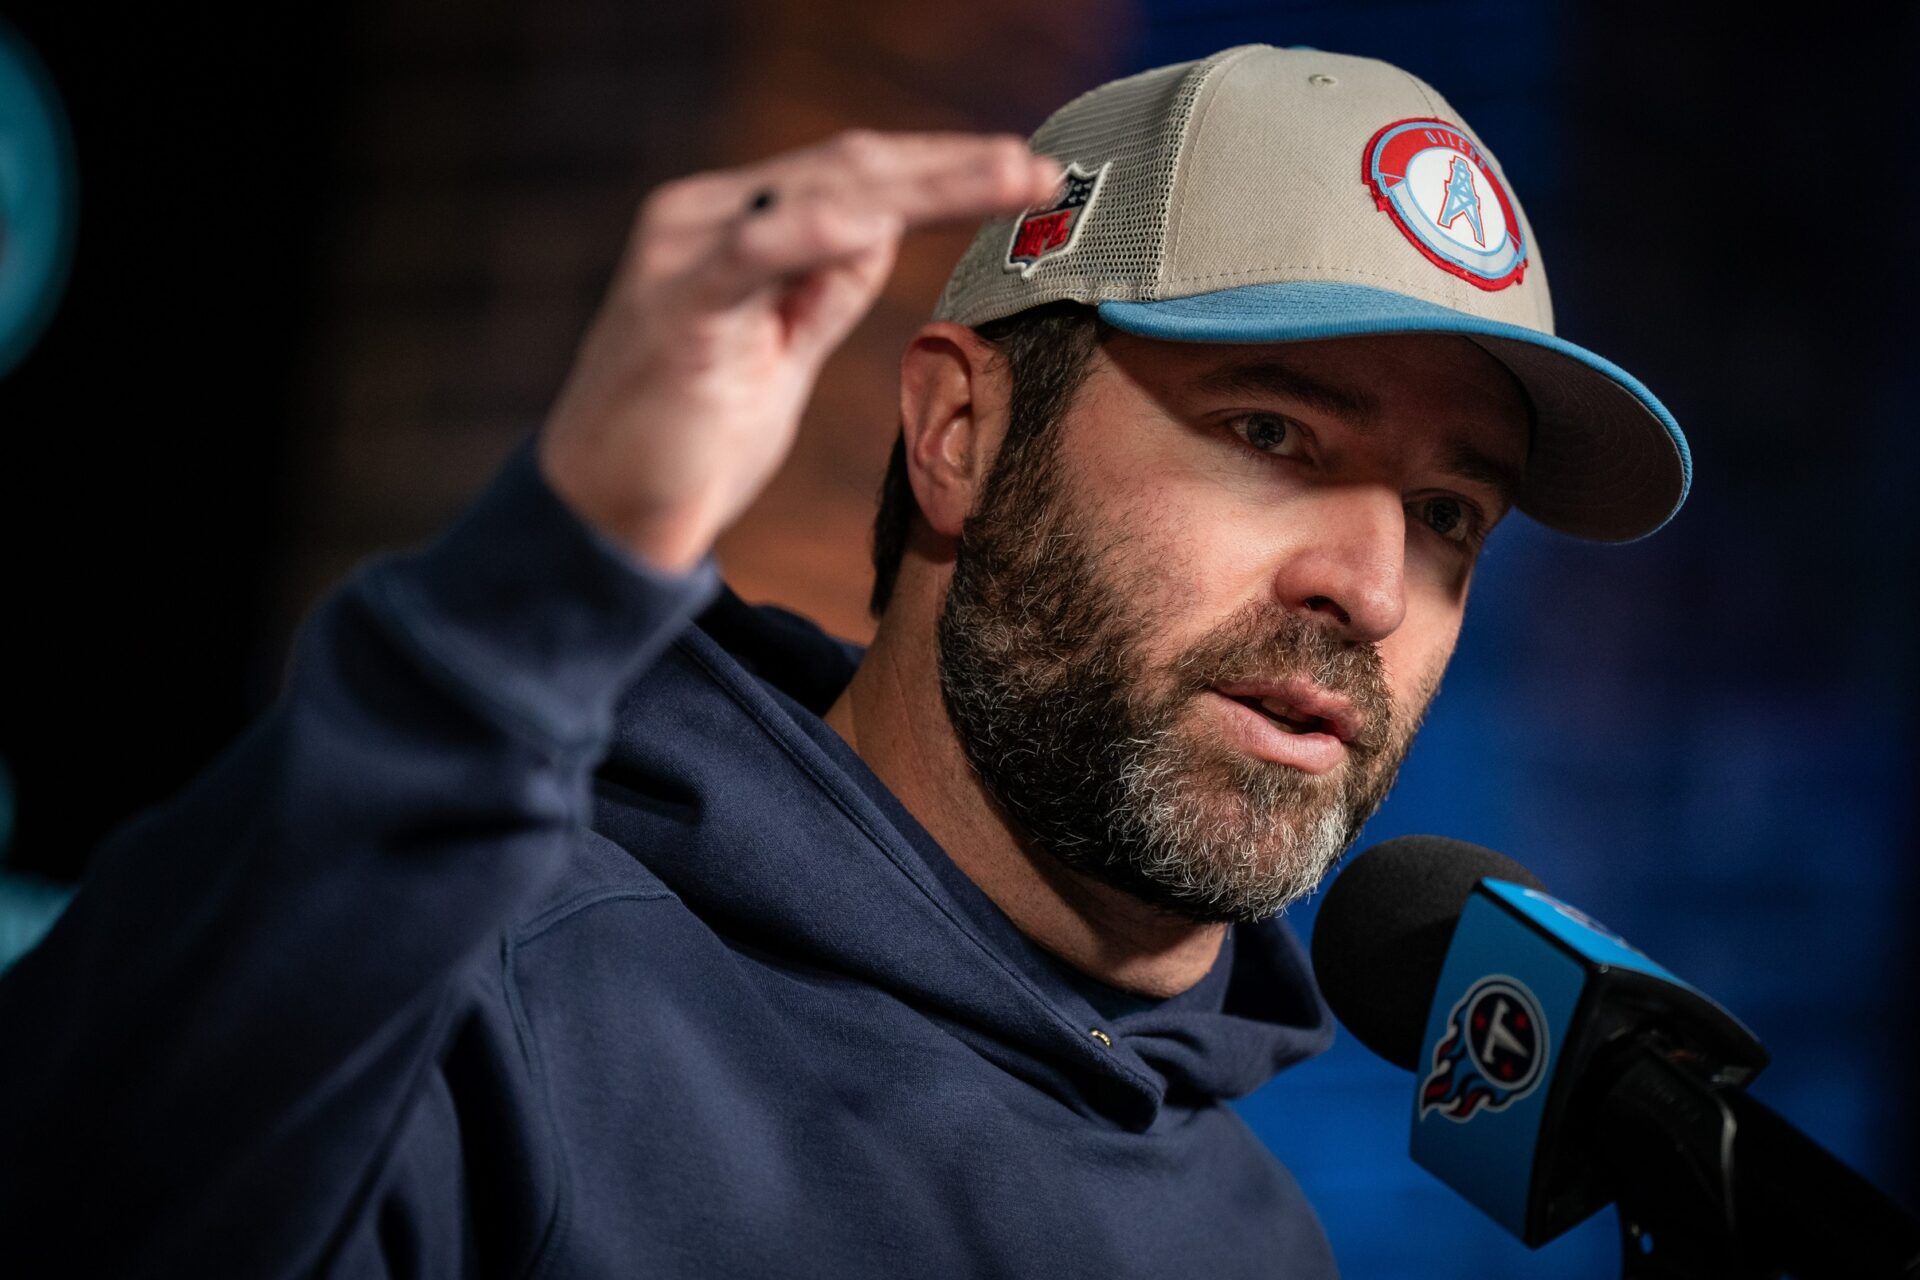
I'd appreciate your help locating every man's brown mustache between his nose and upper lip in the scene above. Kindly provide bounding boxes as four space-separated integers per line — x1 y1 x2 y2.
1175 604 1394 756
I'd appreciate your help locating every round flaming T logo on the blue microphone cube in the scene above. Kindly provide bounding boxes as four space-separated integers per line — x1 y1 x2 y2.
1419 975 1549 1123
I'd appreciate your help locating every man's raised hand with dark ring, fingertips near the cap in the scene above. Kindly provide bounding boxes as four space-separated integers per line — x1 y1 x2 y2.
540 130 1062 572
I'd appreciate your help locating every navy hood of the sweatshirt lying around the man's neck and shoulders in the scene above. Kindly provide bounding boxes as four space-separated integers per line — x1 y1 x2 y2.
595 589 1332 1130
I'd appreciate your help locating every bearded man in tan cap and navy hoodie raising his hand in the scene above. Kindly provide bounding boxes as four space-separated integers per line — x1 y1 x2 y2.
0 46 1688 1278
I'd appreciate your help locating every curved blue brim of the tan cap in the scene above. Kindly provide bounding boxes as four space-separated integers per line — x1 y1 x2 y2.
1098 280 1693 543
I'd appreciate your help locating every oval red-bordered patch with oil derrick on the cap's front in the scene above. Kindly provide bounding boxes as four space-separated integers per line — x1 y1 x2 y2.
1361 119 1526 290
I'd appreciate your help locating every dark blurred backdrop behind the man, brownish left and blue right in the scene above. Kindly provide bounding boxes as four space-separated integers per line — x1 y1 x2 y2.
0 0 1920 1278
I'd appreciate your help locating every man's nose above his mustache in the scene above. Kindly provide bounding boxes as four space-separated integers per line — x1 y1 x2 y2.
1273 486 1407 643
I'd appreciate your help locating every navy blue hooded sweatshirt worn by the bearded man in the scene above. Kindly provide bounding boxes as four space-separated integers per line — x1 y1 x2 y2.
0 438 1334 1278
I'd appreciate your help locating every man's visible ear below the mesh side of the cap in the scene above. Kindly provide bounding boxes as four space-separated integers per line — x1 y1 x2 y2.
900 320 1010 537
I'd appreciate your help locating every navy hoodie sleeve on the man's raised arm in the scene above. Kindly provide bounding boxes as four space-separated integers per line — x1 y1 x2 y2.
0 438 720 1276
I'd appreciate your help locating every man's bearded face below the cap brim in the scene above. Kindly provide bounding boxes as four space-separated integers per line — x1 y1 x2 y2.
937 334 1528 921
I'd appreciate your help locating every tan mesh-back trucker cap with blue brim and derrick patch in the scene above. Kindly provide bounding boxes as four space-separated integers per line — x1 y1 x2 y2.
933 44 1693 541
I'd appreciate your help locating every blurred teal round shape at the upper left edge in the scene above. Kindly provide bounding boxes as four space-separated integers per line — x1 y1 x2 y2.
0 23 79 376
